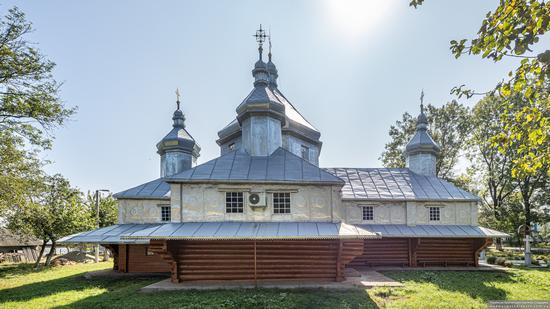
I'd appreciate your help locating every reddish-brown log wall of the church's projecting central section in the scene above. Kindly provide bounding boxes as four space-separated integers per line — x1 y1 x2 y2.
151 240 363 282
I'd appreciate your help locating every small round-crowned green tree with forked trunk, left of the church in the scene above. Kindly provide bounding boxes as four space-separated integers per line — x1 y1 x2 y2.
9 174 93 266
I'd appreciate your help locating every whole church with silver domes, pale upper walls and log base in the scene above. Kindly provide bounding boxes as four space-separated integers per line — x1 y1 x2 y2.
61 28 507 282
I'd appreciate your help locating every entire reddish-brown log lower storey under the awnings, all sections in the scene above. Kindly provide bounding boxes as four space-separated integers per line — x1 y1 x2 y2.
108 238 491 283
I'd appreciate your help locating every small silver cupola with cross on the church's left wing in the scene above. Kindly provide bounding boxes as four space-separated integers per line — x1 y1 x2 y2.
157 90 201 177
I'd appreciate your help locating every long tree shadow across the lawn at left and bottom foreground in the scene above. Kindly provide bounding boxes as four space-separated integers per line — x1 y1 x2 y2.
0 267 377 309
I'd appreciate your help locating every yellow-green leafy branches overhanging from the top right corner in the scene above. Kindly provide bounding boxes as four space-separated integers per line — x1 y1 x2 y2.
410 0 550 190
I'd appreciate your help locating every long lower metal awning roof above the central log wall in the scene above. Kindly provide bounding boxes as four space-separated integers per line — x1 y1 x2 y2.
59 222 380 244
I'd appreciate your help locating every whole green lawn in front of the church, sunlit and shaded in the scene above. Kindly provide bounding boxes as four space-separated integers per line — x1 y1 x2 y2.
0 263 550 309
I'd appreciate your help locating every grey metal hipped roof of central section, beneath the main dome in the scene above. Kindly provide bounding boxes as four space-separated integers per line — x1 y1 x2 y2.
166 148 343 185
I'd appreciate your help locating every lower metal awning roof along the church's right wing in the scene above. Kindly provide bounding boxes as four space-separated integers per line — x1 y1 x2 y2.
357 224 510 238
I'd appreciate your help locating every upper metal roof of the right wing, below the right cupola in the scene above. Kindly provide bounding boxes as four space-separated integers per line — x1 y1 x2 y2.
325 168 479 201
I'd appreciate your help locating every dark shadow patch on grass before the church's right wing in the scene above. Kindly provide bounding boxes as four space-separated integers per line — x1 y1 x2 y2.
384 270 517 301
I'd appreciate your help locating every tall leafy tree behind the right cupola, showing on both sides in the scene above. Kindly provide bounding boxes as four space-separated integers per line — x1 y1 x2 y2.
380 101 471 180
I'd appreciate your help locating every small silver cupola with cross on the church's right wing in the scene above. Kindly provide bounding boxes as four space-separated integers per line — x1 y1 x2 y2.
405 91 440 176
